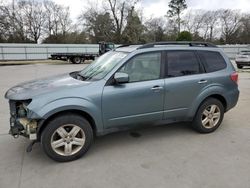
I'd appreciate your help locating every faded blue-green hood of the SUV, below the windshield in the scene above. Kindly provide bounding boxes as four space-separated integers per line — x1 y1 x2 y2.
5 74 90 100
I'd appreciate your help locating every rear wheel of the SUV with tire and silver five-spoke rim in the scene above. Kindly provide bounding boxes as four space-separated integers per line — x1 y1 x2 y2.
192 98 225 133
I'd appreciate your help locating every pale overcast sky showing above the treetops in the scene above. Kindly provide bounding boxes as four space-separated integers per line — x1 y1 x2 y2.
54 0 250 19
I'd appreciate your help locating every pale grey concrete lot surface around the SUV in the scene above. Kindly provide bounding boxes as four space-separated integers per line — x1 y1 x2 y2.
0 64 250 188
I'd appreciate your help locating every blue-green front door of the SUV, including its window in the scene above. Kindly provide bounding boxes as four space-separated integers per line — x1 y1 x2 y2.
102 52 164 128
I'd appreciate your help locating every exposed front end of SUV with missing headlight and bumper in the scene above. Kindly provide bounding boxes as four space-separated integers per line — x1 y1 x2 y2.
9 100 37 140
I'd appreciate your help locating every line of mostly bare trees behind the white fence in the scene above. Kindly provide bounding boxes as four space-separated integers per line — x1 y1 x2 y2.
0 0 250 44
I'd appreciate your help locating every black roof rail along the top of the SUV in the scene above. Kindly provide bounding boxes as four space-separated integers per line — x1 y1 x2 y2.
137 41 217 49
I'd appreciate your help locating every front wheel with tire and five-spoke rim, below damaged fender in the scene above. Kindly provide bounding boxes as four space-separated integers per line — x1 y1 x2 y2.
41 113 93 162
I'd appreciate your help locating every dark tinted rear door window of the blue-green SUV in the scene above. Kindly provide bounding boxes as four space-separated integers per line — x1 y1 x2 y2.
166 51 200 77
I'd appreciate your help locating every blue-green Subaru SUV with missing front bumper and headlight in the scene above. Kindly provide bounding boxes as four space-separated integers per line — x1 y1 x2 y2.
5 42 239 162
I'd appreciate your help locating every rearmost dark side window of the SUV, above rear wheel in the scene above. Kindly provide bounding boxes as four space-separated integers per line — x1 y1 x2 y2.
198 51 226 72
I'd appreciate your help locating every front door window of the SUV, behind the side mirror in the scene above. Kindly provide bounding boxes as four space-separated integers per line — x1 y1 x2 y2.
119 52 161 82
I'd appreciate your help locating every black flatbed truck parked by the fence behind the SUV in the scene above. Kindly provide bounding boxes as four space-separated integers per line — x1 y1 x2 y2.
51 42 115 64
